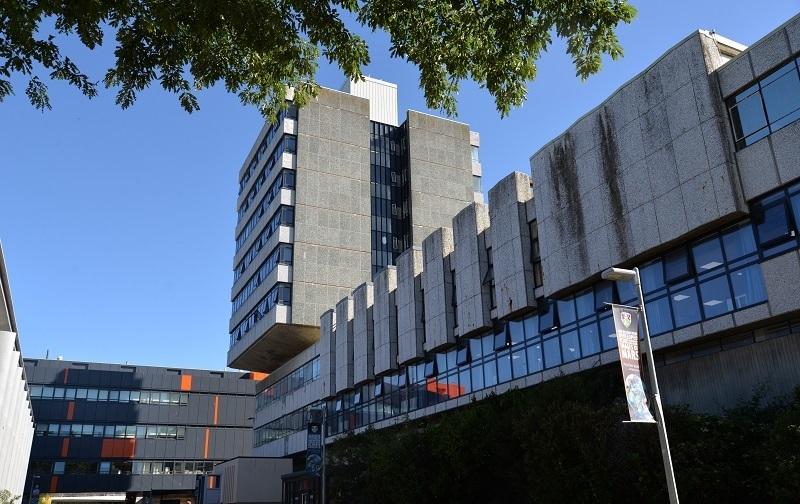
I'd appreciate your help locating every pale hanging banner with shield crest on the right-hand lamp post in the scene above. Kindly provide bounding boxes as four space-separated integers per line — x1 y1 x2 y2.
611 304 655 422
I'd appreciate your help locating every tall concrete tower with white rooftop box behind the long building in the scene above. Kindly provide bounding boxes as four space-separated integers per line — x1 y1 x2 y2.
228 78 482 372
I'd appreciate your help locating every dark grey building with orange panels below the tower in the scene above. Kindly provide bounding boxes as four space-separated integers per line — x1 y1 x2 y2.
20 359 256 504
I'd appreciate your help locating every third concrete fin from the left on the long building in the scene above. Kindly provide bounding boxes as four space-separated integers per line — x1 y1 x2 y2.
353 282 375 385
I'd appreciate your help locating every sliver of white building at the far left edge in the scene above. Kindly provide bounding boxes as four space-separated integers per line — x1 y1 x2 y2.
0 245 33 496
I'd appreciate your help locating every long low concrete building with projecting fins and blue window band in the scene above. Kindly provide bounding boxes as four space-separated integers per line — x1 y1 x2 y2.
244 16 800 490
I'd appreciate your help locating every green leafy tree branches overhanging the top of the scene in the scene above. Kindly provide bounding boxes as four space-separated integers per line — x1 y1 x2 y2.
0 0 636 115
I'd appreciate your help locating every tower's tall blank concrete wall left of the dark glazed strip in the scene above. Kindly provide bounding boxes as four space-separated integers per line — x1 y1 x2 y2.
292 89 372 326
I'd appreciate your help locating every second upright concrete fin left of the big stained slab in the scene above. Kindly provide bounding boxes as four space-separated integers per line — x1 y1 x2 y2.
452 203 492 336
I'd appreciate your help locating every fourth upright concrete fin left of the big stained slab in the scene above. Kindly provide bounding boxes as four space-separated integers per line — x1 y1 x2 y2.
395 247 425 364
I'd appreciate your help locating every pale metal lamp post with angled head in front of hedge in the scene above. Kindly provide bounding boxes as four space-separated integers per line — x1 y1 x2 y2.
601 268 678 504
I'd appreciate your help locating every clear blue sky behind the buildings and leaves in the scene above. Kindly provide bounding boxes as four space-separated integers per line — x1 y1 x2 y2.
0 0 800 369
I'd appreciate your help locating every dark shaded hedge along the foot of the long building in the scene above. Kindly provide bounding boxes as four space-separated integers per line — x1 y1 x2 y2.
329 373 800 504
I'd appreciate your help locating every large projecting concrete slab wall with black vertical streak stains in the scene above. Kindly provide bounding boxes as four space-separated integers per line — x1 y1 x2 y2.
531 32 747 295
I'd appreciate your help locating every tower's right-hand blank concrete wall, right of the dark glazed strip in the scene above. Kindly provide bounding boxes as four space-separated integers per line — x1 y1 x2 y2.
406 111 474 246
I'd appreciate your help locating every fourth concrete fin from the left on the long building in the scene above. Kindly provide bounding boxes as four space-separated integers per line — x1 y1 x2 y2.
373 266 397 375
